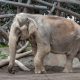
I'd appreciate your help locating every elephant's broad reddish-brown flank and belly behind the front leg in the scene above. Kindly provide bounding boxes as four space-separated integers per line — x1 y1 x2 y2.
48 17 77 52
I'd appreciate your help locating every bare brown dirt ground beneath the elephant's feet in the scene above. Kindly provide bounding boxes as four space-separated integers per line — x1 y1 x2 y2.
0 66 80 80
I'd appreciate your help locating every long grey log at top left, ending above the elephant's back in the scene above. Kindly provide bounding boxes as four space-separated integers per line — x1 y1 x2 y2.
0 0 47 10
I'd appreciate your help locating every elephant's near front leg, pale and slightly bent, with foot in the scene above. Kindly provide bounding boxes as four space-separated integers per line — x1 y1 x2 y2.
34 47 50 74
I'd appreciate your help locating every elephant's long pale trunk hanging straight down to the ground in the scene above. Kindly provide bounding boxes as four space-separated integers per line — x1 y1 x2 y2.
8 32 18 73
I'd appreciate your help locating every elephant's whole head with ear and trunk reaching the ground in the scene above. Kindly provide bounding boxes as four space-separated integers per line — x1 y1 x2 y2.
8 13 37 73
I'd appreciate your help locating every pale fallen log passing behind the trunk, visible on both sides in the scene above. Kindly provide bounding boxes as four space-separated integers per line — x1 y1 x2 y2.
0 50 32 68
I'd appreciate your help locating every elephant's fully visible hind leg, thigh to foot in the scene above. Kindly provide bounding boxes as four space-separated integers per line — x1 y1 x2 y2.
63 41 79 72
